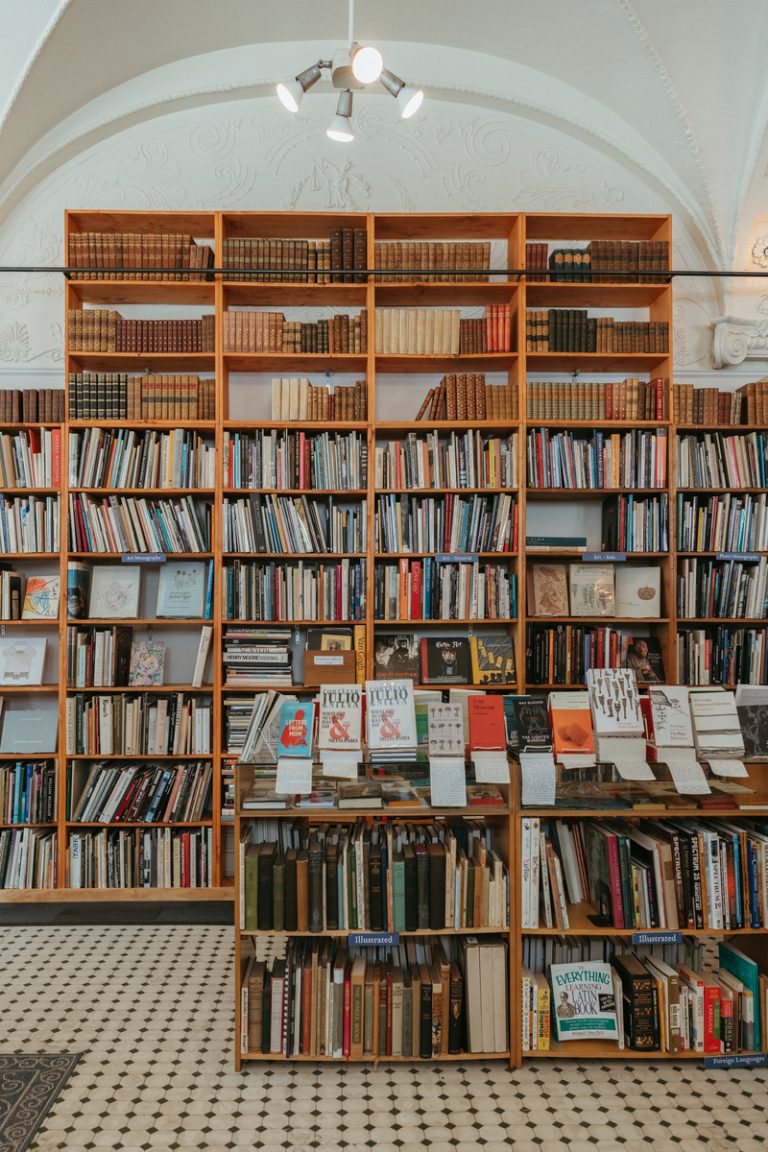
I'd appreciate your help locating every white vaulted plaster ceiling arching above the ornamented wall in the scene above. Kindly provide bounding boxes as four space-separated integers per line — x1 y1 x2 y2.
0 0 768 267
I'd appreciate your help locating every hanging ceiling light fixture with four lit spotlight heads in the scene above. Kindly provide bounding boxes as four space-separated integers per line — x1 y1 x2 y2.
276 0 424 144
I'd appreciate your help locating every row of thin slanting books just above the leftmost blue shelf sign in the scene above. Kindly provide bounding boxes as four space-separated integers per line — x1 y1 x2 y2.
67 492 211 553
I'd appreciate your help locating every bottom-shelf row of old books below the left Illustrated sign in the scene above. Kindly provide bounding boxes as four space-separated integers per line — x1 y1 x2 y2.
239 937 509 1060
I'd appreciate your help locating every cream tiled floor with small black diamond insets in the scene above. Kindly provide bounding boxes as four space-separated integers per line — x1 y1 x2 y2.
0 925 768 1152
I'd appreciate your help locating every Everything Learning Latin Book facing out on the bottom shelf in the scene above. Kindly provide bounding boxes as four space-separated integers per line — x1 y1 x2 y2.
549 961 618 1040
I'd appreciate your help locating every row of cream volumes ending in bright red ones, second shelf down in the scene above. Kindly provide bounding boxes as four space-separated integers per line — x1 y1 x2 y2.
375 304 511 356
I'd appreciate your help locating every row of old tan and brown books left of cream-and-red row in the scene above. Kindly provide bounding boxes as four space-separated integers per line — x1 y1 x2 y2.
223 310 368 355
